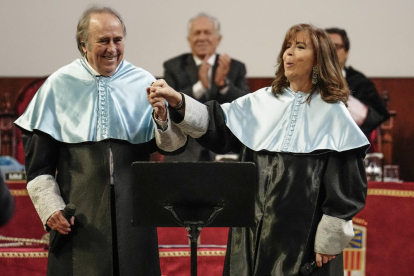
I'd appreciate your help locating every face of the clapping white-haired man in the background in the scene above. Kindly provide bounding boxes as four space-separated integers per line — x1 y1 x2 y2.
187 17 221 59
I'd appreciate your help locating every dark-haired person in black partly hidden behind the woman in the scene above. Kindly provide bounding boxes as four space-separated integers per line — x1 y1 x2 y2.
325 28 390 138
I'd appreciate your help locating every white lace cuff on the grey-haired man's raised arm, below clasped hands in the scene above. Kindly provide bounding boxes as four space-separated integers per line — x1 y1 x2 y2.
152 108 187 152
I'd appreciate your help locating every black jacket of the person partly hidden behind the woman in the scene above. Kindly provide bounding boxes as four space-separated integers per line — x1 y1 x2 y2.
345 67 390 137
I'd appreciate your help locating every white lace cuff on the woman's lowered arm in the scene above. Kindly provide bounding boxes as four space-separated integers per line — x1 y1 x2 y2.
315 215 354 255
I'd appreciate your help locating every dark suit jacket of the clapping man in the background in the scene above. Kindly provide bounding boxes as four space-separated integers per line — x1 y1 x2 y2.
164 53 250 161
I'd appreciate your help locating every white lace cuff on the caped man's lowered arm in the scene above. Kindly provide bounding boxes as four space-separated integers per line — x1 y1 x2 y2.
27 174 66 229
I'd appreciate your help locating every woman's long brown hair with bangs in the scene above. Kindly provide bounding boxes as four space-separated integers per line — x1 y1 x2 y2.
272 24 349 105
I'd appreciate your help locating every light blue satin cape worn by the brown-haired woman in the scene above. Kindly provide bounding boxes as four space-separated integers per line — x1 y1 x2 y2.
221 87 369 153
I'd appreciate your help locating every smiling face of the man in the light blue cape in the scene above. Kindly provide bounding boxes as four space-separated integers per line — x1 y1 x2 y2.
82 13 124 77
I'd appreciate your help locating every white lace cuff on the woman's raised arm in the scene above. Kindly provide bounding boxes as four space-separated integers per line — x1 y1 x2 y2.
177 95 209 138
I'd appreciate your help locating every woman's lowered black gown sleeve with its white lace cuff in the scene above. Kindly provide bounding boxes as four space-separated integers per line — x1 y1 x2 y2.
315 148 367 255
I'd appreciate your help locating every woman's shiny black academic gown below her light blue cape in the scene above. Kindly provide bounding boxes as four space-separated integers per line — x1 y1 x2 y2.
180 102 367 276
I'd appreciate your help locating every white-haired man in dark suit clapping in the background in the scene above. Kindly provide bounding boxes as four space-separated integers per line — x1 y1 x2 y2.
164 13 250 162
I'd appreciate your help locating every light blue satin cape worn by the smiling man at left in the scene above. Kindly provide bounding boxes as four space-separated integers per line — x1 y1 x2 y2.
15 59 155 144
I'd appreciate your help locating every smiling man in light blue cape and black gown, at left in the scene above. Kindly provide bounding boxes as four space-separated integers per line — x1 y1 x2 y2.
15 6 185 276
